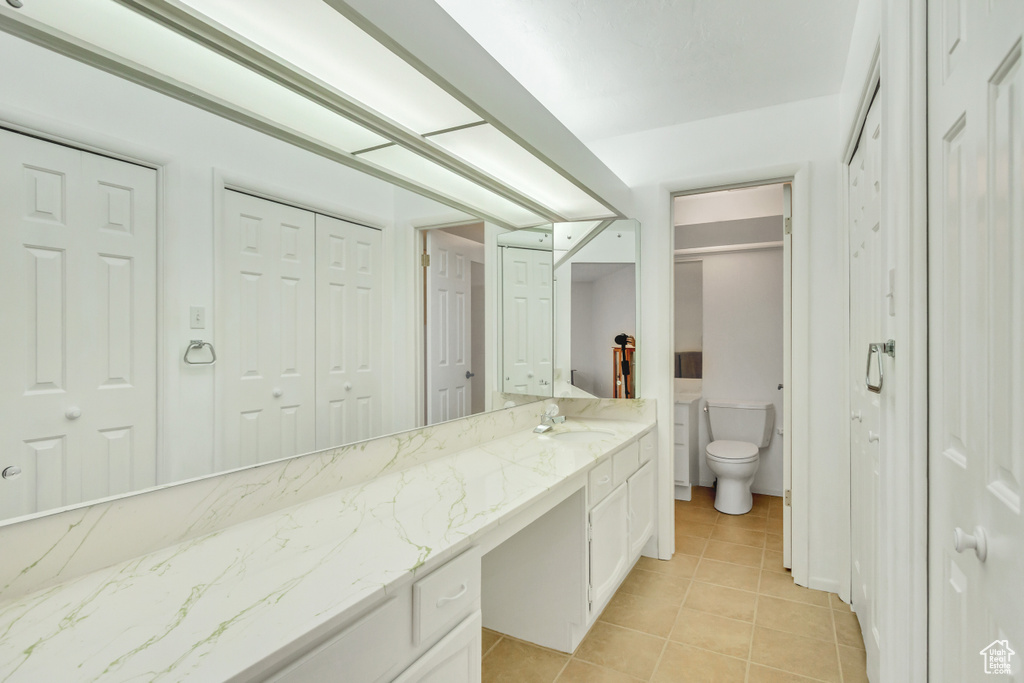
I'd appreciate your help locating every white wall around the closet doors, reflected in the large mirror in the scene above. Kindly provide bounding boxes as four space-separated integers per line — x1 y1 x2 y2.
0 33 452 482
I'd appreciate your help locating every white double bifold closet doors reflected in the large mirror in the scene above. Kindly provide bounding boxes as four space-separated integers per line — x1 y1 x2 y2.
216 190 382 468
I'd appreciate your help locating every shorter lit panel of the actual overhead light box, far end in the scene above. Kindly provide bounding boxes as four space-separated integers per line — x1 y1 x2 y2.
430 124 614 220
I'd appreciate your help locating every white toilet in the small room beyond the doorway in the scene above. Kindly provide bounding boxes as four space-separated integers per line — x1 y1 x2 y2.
705 400 775 515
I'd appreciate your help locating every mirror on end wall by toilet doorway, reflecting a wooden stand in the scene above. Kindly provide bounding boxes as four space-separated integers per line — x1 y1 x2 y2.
554 219 640 398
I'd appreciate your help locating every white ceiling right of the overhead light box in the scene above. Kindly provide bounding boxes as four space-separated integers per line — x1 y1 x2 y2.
436 0 857 142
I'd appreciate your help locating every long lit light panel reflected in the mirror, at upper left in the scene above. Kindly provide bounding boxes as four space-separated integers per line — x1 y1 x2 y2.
9 0 387 153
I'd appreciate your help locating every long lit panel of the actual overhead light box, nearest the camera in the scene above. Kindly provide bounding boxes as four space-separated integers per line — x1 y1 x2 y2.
179 0 480 135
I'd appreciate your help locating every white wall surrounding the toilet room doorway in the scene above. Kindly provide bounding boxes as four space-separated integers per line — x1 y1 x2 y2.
591 96 849 590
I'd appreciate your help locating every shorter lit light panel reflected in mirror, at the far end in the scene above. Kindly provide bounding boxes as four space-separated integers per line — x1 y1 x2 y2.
359 144 547 227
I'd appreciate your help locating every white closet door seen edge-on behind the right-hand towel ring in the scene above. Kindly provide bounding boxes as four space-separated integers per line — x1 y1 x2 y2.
849 93 894 680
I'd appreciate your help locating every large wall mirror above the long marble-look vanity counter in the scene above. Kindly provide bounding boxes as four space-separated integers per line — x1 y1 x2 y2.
0 2 569 523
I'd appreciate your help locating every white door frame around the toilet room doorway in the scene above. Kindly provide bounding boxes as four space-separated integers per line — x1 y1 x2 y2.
671 162 806 590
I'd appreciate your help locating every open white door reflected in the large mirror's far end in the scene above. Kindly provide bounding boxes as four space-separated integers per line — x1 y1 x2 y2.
425 227 484 424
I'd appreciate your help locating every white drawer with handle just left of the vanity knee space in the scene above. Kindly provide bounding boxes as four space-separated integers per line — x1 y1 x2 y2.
413 548 480 645
